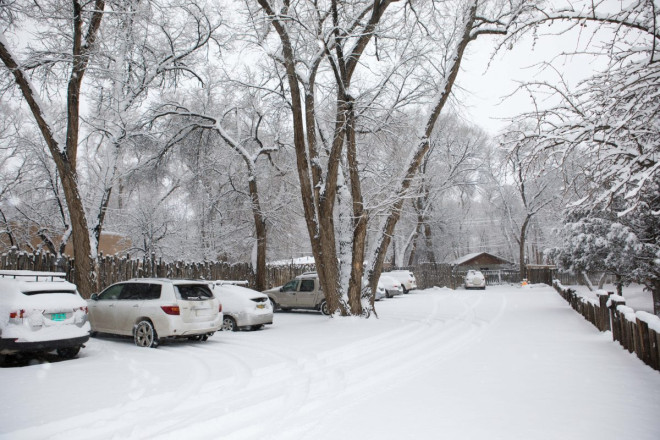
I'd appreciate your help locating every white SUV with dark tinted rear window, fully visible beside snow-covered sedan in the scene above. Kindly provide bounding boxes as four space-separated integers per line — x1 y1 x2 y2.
87 278 222 347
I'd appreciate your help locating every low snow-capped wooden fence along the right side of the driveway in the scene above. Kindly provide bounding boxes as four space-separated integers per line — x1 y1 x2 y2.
553 280 660 371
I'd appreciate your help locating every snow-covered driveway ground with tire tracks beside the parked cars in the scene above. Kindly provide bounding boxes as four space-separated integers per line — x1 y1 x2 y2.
0 286 660 440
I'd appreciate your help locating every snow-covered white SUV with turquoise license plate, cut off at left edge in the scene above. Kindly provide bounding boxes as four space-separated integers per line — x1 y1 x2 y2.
0 270 90 359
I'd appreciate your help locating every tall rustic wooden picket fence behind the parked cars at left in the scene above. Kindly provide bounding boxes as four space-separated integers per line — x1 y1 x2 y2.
0 249 314 291
